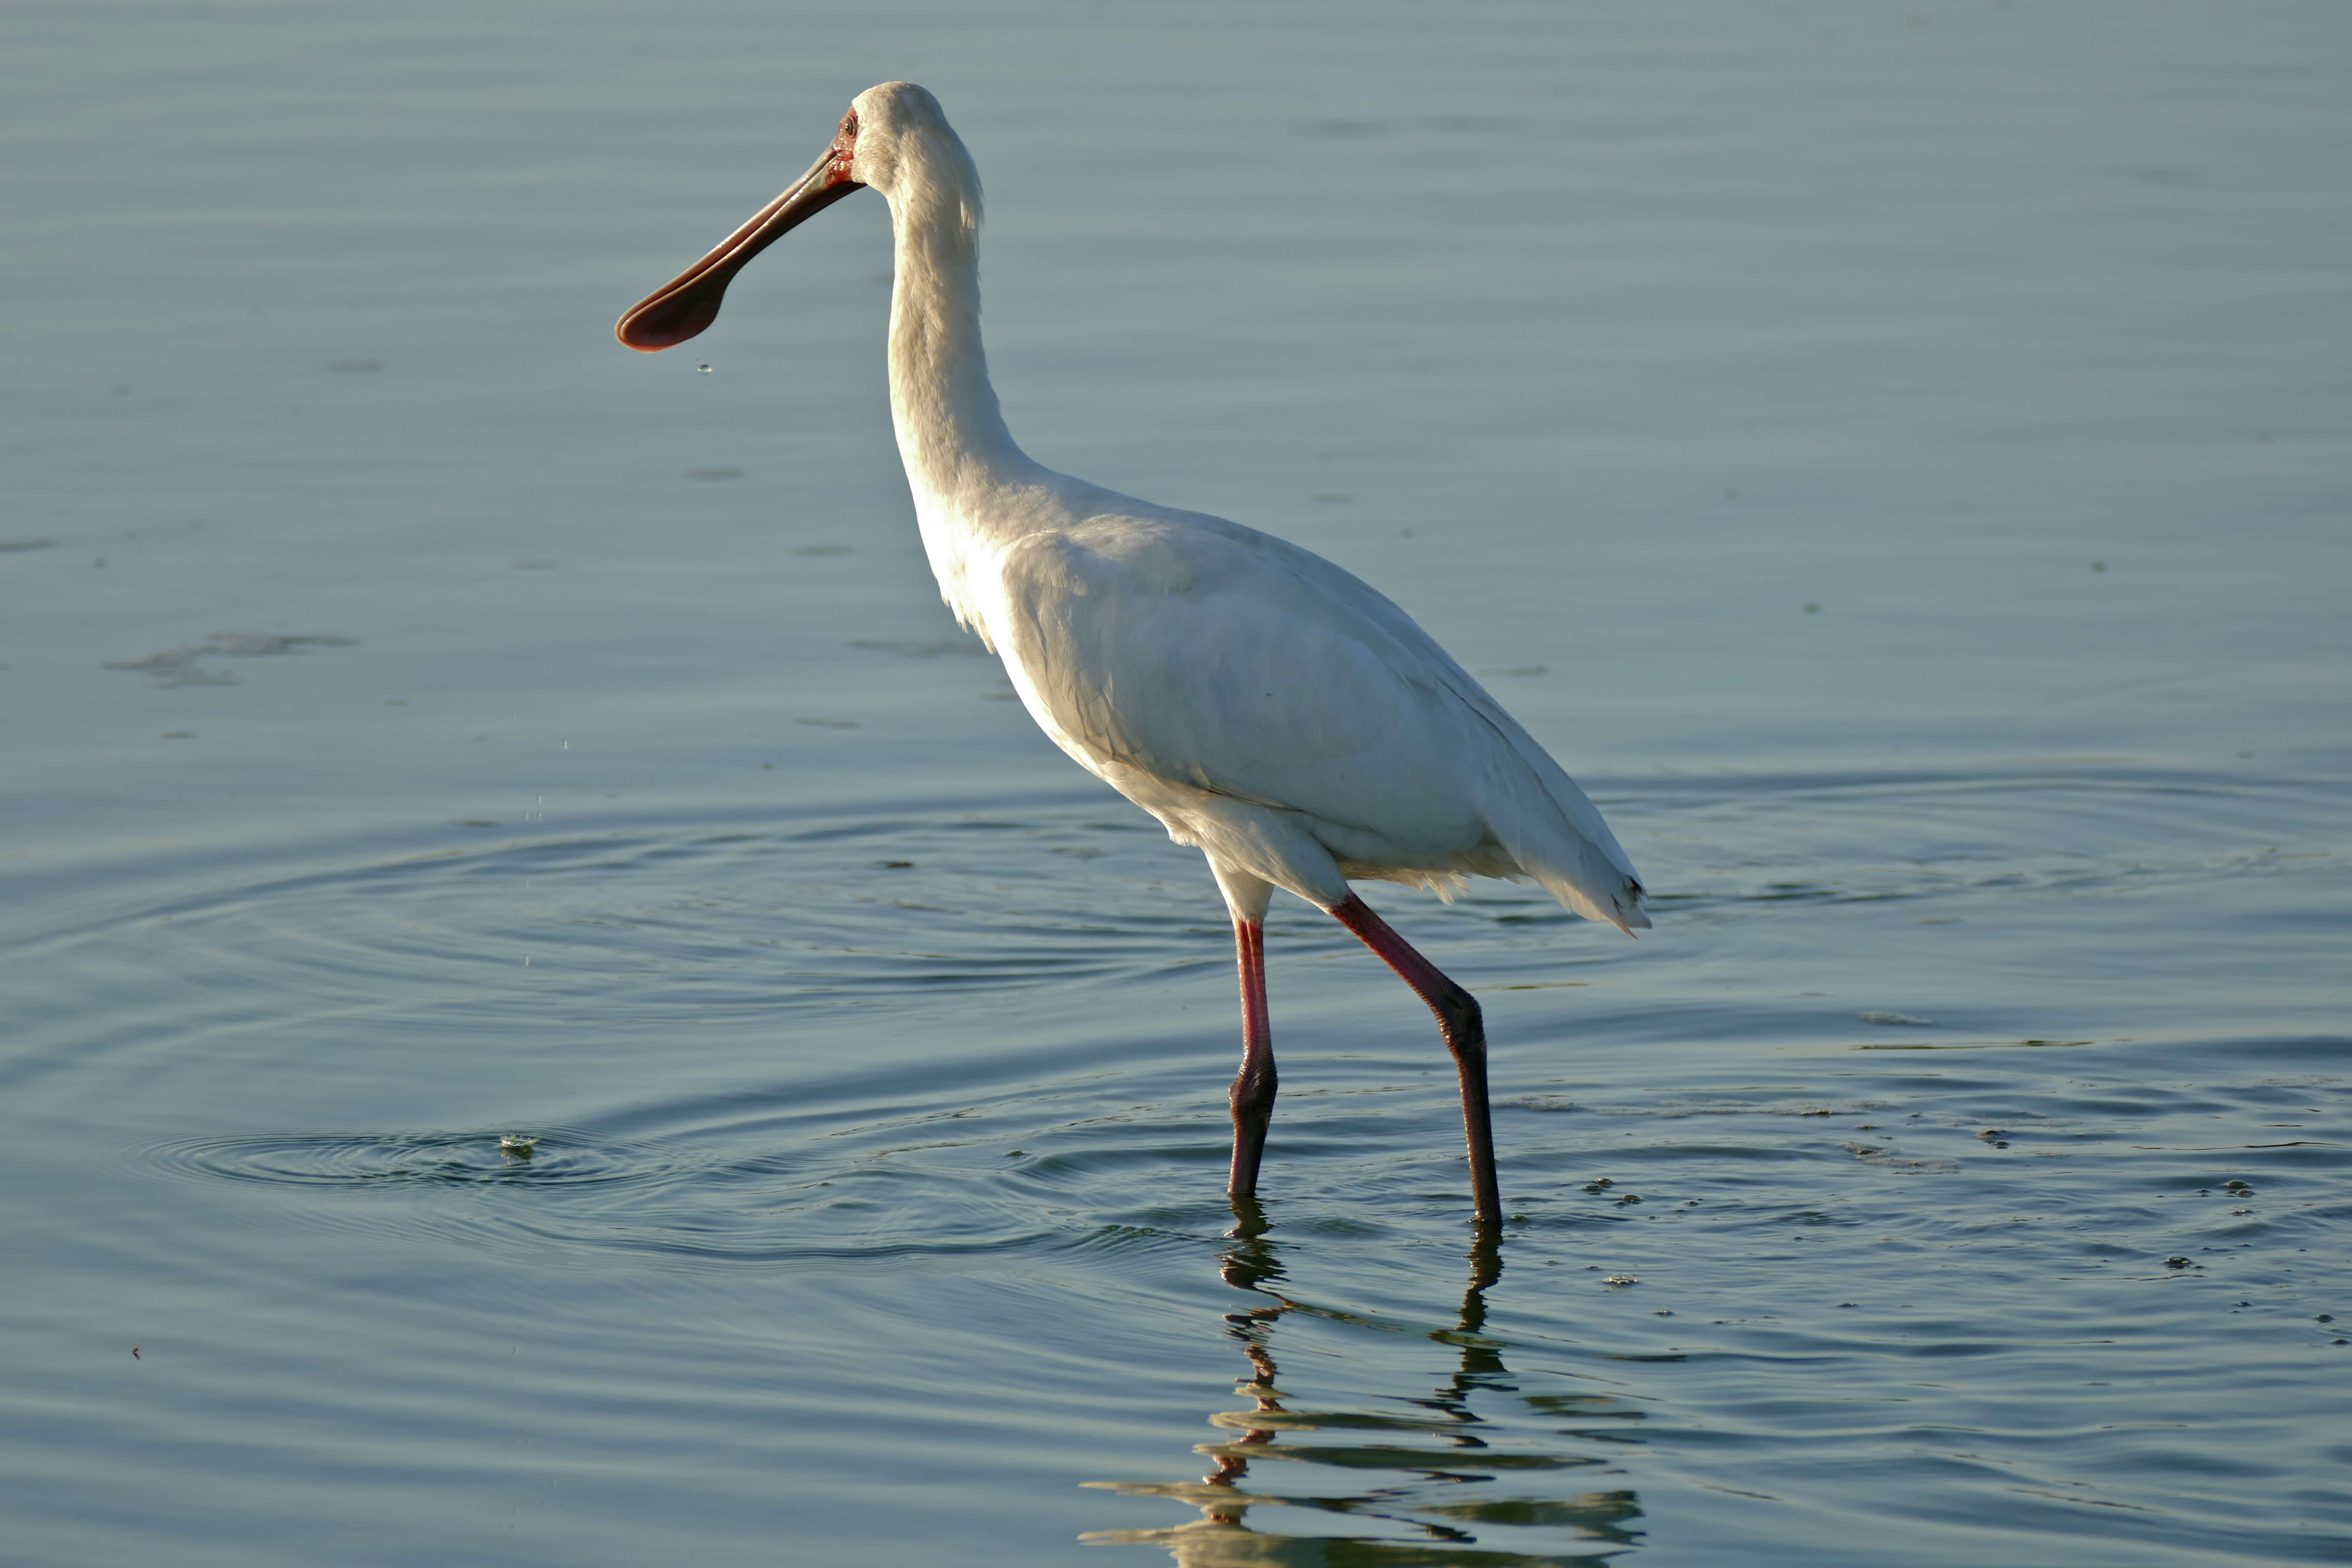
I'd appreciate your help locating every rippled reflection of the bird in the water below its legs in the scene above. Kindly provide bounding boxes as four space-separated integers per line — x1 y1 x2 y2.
1080 1199 1642 1568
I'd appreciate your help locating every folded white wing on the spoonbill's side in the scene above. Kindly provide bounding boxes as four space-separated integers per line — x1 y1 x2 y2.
983 503 1646 924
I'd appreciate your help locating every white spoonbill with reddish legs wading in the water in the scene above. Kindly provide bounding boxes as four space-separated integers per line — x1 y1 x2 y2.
614 82 1649 1225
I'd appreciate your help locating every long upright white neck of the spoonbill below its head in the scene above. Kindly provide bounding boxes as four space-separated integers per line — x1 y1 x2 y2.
889 155 1035 531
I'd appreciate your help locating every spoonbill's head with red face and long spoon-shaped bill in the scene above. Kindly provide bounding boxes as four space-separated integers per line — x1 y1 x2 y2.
614 82 981 352
